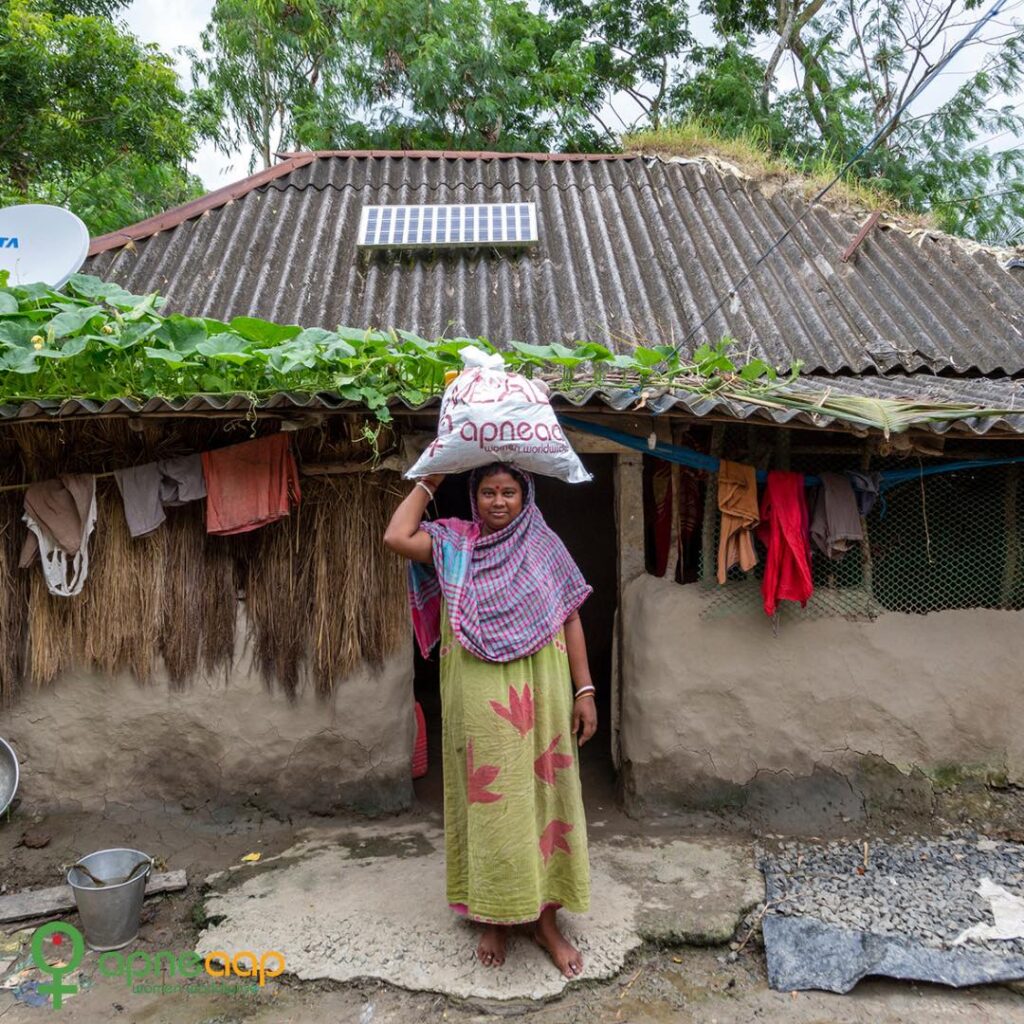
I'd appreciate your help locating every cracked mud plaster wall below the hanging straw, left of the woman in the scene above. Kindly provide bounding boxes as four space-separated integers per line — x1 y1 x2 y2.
0 614 415 814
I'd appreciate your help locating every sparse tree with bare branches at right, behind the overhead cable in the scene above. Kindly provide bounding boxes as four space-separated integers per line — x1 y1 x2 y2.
688 0 1024 239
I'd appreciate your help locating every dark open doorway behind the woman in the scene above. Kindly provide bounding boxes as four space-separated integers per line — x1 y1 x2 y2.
414 455 617 811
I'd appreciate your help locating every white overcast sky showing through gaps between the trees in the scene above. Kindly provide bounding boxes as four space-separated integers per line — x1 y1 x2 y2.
123 0 1024 189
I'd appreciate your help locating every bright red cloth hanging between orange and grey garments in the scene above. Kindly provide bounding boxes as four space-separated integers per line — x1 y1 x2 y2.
758 470 814 615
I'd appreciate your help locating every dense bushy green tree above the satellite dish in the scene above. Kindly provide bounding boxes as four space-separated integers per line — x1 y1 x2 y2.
0 0 207 233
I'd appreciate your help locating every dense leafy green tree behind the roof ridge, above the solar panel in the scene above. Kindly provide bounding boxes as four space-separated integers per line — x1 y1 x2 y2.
342 0 598 151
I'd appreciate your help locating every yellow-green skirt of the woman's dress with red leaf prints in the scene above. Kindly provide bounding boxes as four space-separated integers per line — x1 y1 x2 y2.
440 613 590 925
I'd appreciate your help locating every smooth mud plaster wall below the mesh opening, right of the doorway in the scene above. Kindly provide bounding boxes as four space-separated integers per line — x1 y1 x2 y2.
622 574 1024 824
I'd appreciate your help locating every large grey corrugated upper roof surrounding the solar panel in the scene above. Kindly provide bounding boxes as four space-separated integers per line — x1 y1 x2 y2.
86 153 1024 376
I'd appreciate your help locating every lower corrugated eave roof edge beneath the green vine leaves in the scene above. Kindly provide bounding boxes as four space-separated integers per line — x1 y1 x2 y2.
8 375 1024 435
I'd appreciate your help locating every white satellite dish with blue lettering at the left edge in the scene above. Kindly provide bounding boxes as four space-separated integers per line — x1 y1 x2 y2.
0 203 89 288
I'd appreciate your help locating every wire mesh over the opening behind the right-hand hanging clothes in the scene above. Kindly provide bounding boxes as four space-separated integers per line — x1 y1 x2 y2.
647 425 1024 621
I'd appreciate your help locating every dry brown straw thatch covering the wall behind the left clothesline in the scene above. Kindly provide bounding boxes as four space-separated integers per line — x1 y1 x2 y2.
0 419 409 703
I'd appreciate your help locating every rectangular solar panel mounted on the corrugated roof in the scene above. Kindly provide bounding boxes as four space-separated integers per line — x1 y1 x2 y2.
357 203 540 249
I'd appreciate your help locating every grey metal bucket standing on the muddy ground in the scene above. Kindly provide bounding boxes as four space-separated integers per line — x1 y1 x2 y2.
68 850 153 951
